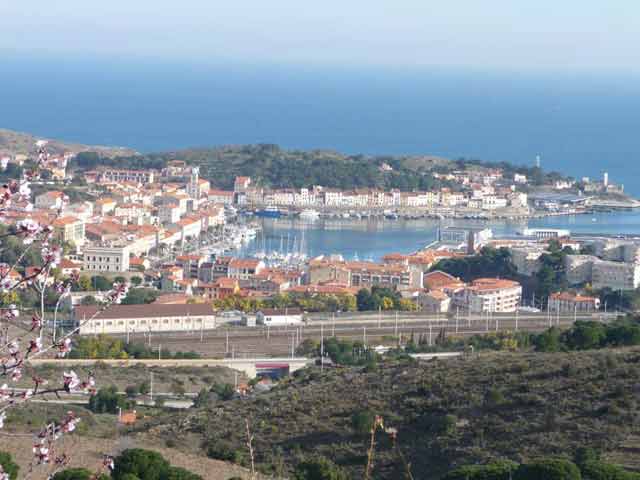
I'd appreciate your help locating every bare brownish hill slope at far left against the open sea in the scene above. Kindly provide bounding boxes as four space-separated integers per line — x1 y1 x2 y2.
0 128 136 157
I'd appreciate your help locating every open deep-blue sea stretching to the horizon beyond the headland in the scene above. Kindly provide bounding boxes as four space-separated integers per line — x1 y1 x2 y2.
0 57 640 195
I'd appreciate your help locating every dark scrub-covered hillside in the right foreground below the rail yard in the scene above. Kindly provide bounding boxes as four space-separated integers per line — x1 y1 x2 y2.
148 349 640 479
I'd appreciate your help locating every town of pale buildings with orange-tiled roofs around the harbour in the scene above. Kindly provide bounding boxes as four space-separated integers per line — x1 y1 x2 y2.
2 146 640 334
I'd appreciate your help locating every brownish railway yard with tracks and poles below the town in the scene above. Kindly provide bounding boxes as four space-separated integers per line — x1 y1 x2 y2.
106 313 617 358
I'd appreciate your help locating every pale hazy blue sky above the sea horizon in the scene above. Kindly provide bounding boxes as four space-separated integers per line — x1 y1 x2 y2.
0 0 640 71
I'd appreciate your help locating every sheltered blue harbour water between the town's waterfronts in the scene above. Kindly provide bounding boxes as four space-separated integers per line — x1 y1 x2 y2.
241 211 640 260
